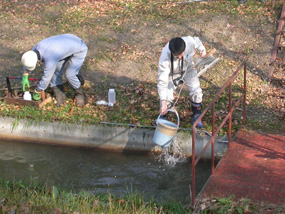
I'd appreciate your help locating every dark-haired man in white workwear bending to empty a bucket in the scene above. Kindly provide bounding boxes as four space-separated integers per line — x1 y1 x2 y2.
157 36 206 128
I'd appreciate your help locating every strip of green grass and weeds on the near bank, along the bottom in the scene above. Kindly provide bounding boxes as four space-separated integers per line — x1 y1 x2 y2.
0 180 283 214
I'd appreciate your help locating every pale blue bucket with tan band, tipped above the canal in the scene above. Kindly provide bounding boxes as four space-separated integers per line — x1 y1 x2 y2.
152 109 179 147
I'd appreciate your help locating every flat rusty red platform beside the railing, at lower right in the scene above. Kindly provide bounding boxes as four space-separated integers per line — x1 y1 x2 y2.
199 131 285 204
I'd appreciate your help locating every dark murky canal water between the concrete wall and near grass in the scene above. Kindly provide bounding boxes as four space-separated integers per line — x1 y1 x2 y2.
0 140 210 203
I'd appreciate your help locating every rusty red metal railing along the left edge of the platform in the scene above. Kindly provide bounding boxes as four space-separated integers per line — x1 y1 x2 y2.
191 62 246 205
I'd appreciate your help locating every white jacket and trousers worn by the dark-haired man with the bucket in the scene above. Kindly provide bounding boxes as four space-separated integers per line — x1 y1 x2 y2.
157 36 206 104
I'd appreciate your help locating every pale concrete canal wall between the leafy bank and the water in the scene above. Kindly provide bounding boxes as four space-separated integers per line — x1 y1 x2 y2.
0 117 228 158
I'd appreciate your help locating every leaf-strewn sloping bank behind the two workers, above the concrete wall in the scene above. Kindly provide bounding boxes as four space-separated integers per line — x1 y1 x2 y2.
0 0 284 134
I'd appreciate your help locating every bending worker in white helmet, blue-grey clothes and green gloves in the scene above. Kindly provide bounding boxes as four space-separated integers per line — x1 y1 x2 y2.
21 34 88 106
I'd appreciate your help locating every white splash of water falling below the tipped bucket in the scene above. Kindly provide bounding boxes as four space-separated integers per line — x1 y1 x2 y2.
157 141 187 167
